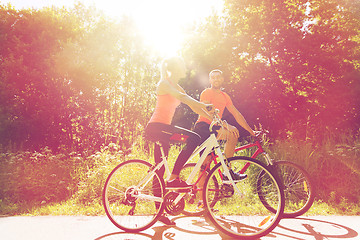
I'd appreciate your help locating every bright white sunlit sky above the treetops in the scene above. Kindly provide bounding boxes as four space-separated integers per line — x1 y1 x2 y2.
0 0 223 56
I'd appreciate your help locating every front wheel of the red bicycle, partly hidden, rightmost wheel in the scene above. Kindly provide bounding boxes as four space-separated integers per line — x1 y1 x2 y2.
258 160 315 218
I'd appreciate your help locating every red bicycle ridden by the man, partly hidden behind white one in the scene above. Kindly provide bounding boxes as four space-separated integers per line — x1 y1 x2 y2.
180 129 315 218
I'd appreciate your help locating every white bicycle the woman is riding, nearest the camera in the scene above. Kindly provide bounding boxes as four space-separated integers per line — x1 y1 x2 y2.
103 111 284 239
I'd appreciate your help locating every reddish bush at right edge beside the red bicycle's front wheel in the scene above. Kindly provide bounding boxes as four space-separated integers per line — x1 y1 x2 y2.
270 131 360 204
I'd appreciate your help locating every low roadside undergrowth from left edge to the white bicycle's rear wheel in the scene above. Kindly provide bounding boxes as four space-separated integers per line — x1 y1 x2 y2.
0 144 135 204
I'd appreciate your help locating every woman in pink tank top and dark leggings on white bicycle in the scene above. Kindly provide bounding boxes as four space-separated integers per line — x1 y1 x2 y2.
145 57 212 224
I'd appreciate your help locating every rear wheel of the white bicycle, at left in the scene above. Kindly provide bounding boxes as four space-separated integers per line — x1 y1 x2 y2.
103 160 165 232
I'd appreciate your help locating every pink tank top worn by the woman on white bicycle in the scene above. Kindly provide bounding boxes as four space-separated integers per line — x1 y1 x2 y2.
149 94 180 125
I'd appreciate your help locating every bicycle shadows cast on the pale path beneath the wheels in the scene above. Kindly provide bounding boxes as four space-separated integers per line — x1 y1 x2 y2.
95 216 359 240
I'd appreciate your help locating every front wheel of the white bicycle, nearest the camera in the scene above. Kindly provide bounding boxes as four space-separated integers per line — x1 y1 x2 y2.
203 156 284 239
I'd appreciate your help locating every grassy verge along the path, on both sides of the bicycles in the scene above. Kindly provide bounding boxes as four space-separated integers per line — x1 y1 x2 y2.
0 132 360 216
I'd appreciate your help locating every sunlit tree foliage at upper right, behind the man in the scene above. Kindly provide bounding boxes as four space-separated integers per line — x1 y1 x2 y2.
183 0 360 140
